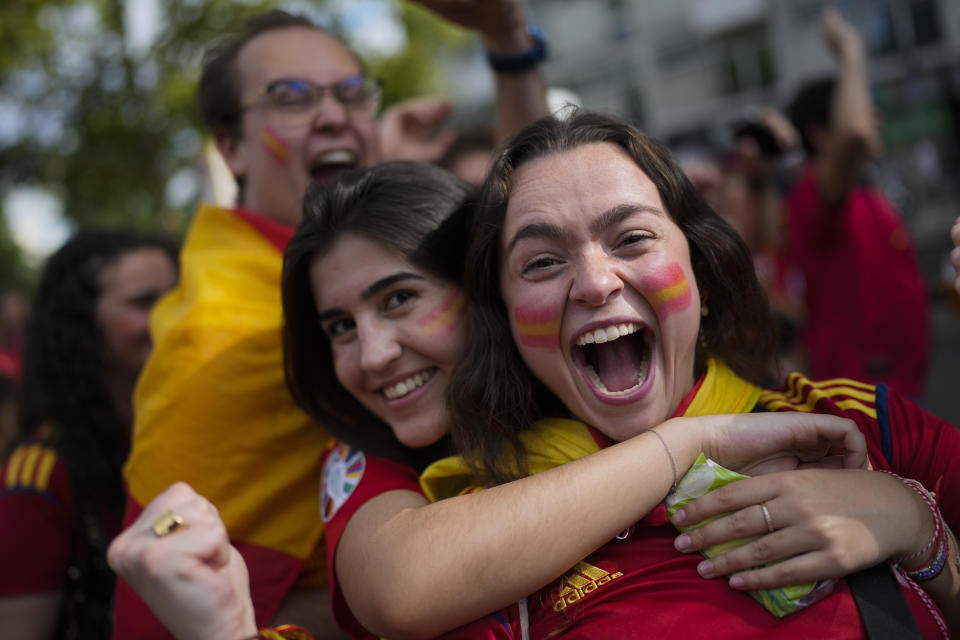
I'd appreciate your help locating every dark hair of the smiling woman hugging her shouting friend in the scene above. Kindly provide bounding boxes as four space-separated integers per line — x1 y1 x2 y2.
282 162 473 468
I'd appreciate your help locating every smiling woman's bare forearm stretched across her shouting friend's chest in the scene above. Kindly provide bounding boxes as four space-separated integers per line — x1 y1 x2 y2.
337 421 701 638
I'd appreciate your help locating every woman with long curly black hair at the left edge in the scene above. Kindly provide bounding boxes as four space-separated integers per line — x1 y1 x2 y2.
0 231 177 639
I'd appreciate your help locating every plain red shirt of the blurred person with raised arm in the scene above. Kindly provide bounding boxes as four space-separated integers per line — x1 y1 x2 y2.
786 166 930 398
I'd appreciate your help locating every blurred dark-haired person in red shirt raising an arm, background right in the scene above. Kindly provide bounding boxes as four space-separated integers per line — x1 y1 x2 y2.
786 8 930 399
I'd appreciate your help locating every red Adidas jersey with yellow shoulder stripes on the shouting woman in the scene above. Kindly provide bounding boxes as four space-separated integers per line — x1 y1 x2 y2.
420 362 960 640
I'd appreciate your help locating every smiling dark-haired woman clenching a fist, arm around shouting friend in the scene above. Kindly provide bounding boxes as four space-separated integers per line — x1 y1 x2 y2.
110 163 863 639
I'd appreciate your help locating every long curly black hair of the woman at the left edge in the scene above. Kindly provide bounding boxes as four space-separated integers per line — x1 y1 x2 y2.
19 230 178 638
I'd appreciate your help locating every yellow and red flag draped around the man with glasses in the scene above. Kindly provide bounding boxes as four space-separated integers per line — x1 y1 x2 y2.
118 206 328 636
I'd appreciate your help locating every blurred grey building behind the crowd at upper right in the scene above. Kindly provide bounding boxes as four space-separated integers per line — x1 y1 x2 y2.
450 0 960 262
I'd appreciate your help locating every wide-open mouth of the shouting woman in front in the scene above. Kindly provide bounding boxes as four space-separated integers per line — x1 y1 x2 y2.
572 322 653 398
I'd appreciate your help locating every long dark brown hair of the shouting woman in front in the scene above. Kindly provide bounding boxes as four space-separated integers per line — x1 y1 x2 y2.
448 111 776 484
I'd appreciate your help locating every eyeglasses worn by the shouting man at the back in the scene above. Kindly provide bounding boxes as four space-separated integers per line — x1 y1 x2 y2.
243 75 382 127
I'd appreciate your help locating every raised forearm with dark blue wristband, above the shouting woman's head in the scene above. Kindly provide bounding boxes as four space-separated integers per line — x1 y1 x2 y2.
483 22 549 145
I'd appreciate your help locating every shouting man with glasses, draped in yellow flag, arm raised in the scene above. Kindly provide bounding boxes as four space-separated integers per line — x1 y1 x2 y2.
114 6 546 638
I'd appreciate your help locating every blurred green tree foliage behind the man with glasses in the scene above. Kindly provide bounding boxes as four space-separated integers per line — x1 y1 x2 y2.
0 0 463 286
